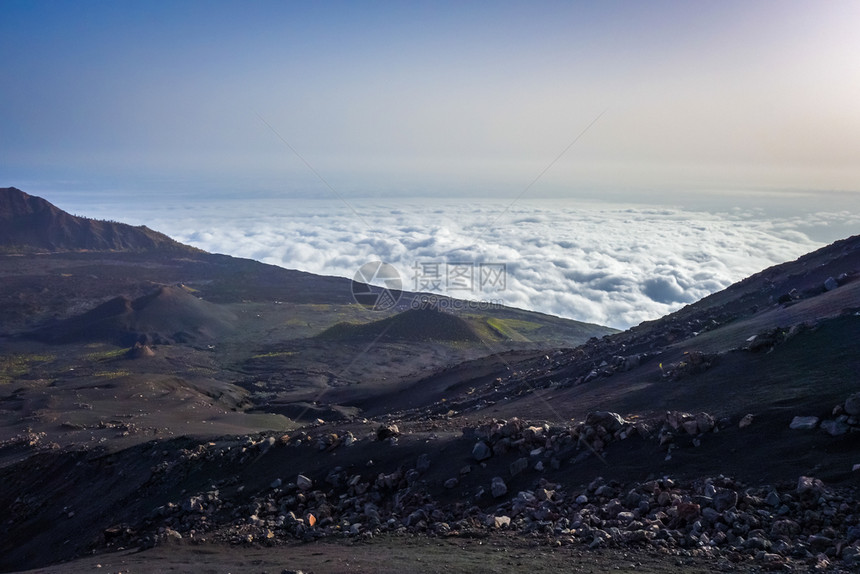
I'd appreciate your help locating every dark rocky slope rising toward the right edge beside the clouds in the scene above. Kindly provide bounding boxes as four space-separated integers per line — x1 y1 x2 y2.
375 232 860 481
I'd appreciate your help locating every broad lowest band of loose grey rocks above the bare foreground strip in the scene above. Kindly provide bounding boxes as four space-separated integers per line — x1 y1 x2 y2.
139 462 860 569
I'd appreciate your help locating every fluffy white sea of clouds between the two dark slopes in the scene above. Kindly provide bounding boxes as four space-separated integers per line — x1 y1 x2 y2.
72 199 860 328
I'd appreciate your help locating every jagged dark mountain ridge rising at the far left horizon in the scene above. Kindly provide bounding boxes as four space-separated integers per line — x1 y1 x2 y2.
0 187 193 252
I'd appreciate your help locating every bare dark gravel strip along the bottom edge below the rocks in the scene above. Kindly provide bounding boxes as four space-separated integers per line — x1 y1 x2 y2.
18 536 760 574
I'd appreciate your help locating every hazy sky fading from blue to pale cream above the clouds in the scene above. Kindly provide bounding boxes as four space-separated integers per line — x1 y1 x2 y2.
5 0 860 203
